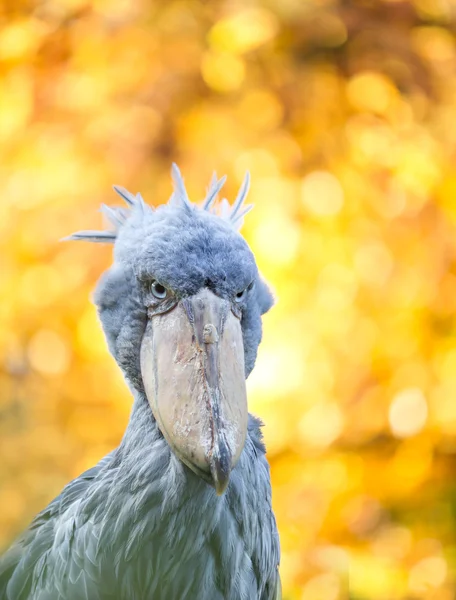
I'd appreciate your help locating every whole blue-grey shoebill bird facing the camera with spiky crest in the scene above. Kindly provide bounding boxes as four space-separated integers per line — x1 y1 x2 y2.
0 164 282 600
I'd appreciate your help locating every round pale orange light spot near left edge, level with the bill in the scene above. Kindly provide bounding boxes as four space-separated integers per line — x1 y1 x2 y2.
27 329 70 375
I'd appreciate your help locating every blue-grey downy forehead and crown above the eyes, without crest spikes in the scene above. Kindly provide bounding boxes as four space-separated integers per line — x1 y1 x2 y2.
116 207 256 293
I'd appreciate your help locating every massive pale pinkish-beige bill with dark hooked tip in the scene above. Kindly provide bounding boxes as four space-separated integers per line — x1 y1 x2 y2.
141 288 248 494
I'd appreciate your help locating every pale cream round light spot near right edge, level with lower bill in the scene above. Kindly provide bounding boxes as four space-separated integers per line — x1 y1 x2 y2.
388 388 428 438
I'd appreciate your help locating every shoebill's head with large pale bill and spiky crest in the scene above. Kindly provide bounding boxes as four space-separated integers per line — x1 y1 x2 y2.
67 166 273 494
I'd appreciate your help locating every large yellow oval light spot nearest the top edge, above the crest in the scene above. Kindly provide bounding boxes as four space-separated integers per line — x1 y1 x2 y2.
209 8 278 54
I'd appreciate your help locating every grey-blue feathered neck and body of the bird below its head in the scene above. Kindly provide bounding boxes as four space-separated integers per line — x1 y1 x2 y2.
0 408 280 600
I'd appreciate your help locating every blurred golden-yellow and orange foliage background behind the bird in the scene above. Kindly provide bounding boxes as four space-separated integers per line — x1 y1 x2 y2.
0 0 456 600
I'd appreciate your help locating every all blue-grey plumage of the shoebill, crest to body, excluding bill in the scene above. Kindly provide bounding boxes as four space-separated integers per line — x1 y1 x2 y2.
0 166 281 600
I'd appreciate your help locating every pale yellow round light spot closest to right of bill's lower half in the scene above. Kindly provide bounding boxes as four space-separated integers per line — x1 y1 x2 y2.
299 402 344 448
